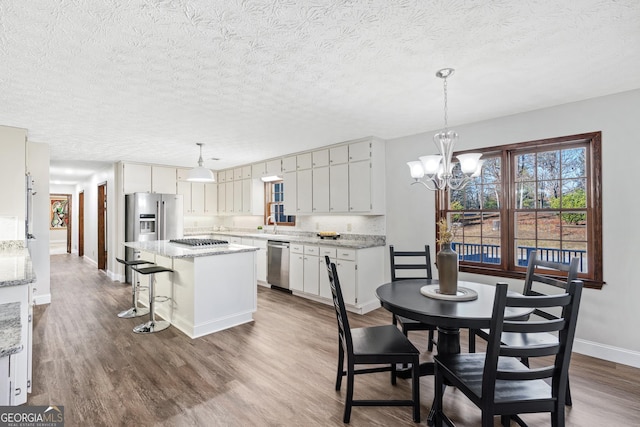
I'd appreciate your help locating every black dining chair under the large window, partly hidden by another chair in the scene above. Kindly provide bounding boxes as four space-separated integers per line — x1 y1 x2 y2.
469 251 579 406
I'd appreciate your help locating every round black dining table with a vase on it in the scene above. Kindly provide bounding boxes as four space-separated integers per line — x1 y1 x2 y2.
376 279 533 425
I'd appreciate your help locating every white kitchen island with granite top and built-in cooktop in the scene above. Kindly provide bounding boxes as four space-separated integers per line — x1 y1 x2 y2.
124 240 258 338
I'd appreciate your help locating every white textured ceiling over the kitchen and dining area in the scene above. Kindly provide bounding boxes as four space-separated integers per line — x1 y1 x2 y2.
0 0 640 182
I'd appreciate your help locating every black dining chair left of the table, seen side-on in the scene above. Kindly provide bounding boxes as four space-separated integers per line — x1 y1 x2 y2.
325 256 420 423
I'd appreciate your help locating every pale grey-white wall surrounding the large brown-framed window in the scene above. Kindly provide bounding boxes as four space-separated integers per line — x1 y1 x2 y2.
387 90 640 367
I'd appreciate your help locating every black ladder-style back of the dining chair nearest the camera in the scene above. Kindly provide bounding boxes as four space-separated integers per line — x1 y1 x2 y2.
482 280 583 413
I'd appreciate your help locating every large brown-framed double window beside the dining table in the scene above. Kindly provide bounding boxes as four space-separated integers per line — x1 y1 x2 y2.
436 132 604 288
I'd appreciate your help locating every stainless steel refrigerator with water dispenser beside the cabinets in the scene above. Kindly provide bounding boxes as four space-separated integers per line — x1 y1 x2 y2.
125 193 184 283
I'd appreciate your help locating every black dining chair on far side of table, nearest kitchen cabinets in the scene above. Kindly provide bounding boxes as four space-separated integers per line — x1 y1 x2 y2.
389 245 436 351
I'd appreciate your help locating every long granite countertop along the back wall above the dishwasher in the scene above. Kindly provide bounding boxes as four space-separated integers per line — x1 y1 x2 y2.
185 230 386 249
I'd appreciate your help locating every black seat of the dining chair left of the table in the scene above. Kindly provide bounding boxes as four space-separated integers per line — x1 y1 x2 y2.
351 325 420 363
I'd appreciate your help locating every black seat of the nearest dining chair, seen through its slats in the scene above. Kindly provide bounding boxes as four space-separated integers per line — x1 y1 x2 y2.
434 353 555 404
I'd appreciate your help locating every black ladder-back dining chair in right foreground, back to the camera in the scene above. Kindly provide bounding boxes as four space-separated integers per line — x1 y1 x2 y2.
434 280 582 427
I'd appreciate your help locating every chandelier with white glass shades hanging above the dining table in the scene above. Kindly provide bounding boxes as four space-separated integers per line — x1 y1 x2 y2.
407 68 484 191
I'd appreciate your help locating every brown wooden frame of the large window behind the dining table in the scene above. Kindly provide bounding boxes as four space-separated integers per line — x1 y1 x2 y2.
435 131 605 289
